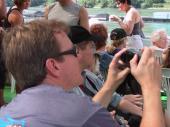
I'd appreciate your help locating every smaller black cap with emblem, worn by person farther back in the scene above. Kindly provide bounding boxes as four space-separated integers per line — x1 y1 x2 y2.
110 28 127 40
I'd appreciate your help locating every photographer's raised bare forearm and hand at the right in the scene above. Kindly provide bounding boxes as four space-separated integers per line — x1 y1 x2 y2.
130 48 165 127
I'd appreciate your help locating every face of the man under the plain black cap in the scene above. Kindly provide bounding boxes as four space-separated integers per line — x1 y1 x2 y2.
78 41 95 71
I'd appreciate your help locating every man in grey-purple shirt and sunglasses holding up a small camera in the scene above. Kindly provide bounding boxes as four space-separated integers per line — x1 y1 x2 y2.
0 21 164 127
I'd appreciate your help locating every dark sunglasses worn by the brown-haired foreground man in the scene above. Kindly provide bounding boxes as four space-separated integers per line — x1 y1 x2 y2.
57 45 79 57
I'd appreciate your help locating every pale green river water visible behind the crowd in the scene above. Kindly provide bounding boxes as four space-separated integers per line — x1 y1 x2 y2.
25 6 170 36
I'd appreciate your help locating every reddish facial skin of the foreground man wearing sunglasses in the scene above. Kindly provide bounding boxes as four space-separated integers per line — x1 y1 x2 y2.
55 32 83 89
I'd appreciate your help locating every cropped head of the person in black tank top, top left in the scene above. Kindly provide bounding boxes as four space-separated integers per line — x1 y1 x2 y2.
13 0 31 9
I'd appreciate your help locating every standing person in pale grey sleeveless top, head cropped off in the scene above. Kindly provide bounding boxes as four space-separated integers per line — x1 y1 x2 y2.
45 0 89 30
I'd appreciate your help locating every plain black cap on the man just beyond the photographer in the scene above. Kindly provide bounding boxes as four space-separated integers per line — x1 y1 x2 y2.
68 26 100 44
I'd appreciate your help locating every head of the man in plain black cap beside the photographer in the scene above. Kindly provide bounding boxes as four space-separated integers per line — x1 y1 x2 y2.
69 26 98 71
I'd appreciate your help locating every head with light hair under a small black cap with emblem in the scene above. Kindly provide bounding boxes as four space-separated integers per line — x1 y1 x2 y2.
106 28 127 52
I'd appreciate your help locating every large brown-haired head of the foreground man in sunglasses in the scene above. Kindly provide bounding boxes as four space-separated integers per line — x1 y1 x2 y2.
3 20 82 89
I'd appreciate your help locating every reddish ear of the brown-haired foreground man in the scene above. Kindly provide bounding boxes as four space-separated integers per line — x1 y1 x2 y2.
45 58 60 77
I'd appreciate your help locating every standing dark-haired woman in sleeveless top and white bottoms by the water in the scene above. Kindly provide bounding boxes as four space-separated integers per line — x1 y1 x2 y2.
110 0 144 49
